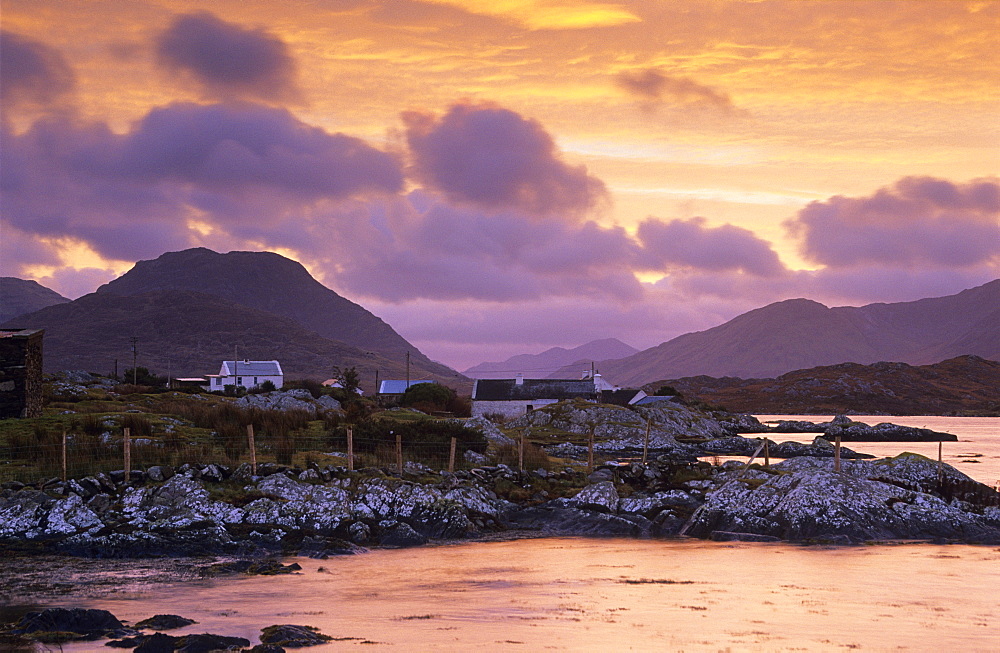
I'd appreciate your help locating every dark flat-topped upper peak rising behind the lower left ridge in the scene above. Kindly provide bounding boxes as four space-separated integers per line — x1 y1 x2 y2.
90 247 456 379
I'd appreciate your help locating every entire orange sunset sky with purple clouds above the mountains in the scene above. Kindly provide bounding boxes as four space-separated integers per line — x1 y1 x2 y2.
0 0 1000 370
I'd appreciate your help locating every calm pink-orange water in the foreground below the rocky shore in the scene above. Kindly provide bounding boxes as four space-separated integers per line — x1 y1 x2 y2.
31 538 1000 651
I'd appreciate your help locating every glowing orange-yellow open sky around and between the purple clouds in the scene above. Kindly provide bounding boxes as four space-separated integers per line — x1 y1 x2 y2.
0 0 1000 366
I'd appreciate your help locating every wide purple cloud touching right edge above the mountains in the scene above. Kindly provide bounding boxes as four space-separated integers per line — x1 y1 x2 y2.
785 177 1000 268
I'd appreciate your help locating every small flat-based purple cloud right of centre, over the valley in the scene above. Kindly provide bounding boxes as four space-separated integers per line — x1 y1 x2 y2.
638 218 786 276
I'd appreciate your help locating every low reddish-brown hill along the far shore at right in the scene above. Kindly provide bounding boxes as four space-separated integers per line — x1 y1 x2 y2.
646 356 1000 415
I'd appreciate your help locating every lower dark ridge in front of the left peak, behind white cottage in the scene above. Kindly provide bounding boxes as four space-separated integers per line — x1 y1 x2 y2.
0 290 463 389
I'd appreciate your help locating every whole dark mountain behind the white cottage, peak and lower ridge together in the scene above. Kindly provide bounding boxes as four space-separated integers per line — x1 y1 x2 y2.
3 248 469 390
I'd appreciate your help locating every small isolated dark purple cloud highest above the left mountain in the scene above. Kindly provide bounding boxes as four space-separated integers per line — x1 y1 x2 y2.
156 11 299 102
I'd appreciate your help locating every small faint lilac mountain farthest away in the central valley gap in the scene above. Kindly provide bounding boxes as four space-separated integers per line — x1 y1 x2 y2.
463 338 639 379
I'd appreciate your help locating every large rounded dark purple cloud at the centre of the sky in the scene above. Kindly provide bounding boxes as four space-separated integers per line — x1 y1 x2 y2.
403 104 606 215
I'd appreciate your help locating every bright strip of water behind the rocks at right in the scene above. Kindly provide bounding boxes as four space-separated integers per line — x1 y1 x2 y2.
751 415 1000 487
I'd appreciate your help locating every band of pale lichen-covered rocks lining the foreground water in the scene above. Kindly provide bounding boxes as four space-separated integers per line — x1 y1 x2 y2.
0 437 1000 557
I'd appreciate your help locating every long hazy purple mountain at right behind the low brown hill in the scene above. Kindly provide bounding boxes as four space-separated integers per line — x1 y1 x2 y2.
566 279 1000 386
